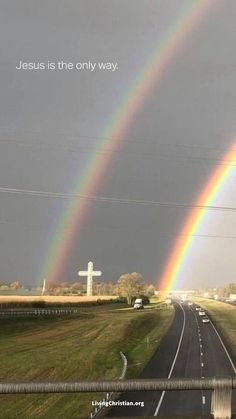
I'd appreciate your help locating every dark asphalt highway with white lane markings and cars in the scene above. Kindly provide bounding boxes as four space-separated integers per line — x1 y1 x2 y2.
107 304 236 418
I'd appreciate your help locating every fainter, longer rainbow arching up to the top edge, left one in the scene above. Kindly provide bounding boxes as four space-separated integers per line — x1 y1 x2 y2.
38 0 215 283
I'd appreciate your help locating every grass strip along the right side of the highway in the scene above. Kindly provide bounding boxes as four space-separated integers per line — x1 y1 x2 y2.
194 298 236 364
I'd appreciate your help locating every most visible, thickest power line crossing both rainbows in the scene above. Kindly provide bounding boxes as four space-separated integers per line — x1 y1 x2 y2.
0 187 236 212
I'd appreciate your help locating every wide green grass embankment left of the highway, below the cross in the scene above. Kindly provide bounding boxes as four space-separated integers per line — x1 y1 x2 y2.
0 304 173 419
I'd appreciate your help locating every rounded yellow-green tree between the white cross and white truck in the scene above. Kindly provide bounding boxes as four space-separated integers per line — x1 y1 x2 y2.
117 272 143 305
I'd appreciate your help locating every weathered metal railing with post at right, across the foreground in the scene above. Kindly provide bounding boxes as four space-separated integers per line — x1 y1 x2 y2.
0 376 236 419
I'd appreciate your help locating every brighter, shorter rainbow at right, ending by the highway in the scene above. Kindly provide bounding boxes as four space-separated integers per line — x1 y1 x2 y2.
159 145 236 293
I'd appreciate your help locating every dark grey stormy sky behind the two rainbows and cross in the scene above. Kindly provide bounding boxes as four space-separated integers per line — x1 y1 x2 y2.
0 0 236 288
